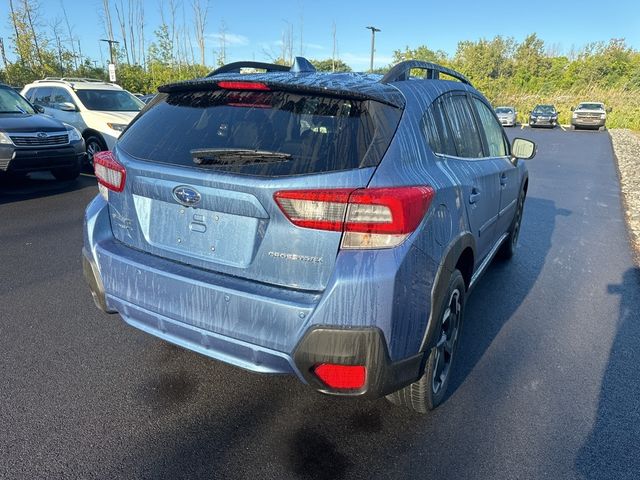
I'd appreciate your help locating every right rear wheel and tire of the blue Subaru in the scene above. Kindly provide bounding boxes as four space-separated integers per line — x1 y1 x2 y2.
386 270 466 413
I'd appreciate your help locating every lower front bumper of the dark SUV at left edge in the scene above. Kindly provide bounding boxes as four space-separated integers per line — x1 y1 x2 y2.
0 142 85 172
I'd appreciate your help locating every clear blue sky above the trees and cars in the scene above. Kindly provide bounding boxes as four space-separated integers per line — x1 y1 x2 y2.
0 0 640 70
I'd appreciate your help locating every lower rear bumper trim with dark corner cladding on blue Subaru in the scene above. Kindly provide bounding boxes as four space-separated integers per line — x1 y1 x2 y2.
83 250 423 398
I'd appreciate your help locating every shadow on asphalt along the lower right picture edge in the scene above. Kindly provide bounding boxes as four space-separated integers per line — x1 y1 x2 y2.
576 268 640 480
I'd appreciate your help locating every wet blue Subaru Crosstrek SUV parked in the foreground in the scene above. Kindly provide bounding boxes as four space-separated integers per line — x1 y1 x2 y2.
83 58 535 412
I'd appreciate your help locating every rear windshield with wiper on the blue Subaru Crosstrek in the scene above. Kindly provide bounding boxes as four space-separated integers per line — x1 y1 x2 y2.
118 90 402 176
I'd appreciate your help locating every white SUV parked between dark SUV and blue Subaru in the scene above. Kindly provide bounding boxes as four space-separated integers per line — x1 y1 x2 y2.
21 77 144 163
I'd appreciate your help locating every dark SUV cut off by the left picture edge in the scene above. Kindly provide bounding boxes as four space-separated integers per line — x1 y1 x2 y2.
0 84 85 180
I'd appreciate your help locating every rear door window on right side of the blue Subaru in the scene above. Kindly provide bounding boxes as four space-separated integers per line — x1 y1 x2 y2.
442 95 485 158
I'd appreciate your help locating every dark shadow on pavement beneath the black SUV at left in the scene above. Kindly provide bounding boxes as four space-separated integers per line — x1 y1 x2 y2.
0 172 96 205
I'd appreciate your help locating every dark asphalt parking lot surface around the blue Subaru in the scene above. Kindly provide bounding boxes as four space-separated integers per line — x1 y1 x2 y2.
0 128 640 479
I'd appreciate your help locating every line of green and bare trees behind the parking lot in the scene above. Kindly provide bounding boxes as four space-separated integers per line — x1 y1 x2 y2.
0 0 640 129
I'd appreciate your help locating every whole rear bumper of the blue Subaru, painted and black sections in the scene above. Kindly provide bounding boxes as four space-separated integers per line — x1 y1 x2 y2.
83 197 430 397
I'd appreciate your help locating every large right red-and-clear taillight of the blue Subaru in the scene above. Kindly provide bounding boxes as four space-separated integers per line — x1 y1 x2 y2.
274 186 435 248
